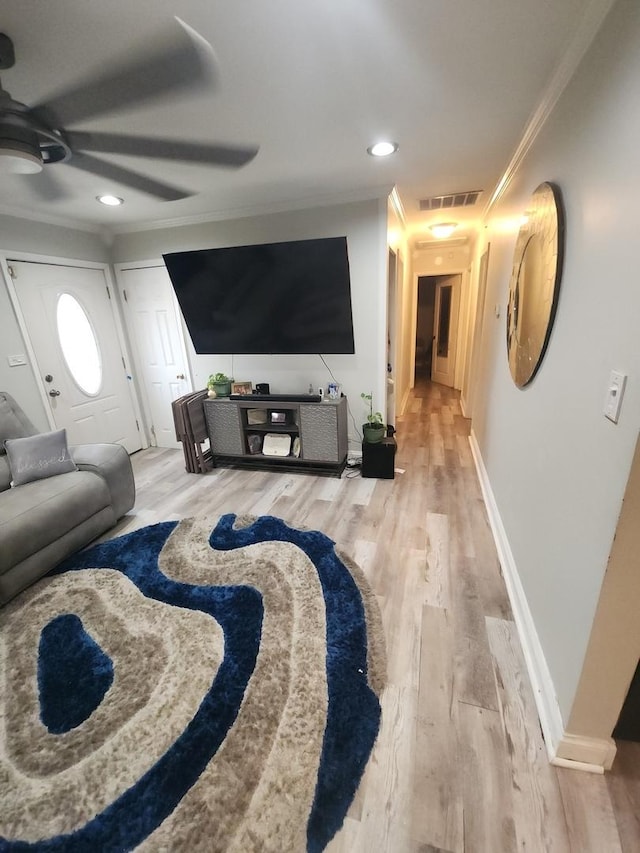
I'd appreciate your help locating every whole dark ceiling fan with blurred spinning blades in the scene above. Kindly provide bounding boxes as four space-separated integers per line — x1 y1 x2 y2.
0 18 258 201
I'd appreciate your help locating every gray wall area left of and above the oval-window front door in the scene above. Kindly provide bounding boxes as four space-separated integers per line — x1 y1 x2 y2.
0 215 108 430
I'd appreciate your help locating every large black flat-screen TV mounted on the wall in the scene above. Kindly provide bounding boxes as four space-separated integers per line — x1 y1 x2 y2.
163 237 355 355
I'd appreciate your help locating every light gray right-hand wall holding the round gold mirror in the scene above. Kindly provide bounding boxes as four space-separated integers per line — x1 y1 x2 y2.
473 0 640 724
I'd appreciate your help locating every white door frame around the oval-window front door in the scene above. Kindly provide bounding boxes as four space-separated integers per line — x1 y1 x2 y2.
0 249 149 449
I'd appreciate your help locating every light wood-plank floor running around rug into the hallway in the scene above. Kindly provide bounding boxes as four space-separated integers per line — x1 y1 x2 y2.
112 383 640 853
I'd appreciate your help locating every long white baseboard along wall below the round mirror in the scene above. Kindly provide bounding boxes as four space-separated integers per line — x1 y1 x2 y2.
469 430 615 773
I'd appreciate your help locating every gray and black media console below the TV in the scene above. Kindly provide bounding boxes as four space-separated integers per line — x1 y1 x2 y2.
204 396 348 476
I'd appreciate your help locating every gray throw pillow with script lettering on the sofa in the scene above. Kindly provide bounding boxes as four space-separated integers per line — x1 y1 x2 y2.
4 429 77 486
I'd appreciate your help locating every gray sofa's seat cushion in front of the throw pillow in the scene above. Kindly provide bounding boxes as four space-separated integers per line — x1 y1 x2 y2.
0 471 111 574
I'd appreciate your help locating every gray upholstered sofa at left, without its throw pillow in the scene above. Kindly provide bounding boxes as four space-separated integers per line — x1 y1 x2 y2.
0 391 135 605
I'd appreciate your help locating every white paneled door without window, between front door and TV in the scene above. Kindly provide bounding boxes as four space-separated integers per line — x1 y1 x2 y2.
118 265 192 447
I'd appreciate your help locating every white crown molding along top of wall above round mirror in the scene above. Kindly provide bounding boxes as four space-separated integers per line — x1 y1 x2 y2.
482 0 615 213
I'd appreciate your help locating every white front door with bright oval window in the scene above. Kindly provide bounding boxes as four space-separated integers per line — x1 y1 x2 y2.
9 261 142 453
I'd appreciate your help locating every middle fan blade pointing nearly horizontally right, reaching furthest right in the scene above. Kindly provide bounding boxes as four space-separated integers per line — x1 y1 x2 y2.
65 130 259 168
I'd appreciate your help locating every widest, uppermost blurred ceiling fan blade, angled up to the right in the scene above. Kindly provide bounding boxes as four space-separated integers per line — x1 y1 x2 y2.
30 18 216 129
